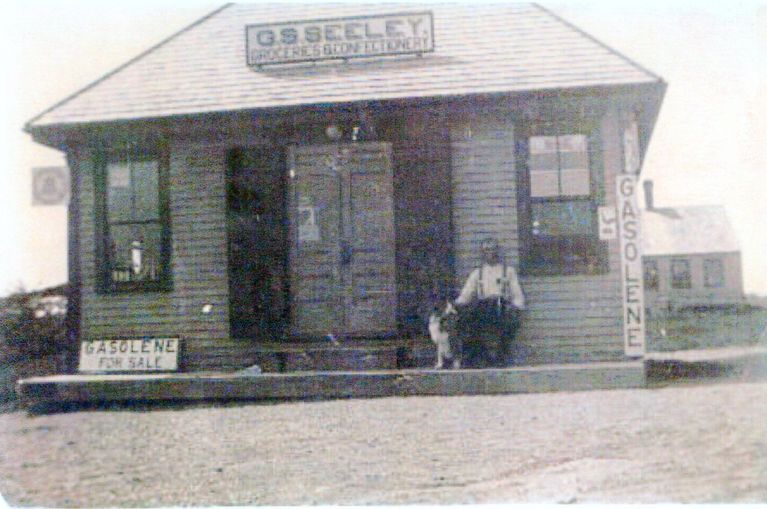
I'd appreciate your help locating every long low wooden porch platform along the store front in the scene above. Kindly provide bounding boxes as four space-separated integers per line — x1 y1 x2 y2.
17 361 646 408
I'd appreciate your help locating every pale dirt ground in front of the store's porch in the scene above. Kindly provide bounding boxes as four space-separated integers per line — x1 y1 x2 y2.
0 380 767 507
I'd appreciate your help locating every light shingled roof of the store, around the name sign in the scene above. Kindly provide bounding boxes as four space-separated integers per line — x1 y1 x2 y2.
26 3 662 129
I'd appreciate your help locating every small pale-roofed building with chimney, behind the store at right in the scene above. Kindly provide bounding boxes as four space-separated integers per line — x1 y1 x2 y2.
642 181 745 310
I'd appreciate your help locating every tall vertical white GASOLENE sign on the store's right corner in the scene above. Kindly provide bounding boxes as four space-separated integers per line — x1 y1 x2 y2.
617 173 645 357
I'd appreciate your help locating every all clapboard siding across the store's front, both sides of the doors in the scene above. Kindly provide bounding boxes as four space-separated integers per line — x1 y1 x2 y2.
74 93 636 370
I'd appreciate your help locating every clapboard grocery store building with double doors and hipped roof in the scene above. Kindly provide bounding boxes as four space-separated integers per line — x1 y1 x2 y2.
26 4 665 371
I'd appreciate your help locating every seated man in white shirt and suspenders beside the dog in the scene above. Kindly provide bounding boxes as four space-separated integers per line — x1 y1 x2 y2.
455 238 525 367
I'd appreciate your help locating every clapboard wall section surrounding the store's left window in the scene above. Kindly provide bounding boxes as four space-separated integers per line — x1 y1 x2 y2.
73 139 234 370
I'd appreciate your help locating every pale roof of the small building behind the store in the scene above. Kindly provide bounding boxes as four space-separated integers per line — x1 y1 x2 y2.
642 205 740 256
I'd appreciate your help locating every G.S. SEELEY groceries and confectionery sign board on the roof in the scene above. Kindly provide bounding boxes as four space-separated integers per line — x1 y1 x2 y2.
245 12 434 67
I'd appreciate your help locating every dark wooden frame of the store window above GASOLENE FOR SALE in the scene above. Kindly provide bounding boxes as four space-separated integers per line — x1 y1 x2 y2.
94 146 173 294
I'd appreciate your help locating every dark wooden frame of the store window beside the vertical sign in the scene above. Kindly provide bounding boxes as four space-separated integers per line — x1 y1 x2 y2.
514 117 609 276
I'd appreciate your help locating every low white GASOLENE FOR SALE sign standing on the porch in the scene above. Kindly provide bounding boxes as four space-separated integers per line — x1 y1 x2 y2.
78 338 179 373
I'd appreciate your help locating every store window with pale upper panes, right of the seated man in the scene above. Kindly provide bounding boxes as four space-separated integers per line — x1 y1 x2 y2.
517 126 607 275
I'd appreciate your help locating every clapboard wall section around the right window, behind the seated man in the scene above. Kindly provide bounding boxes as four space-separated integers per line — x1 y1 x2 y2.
451 105 623 363
